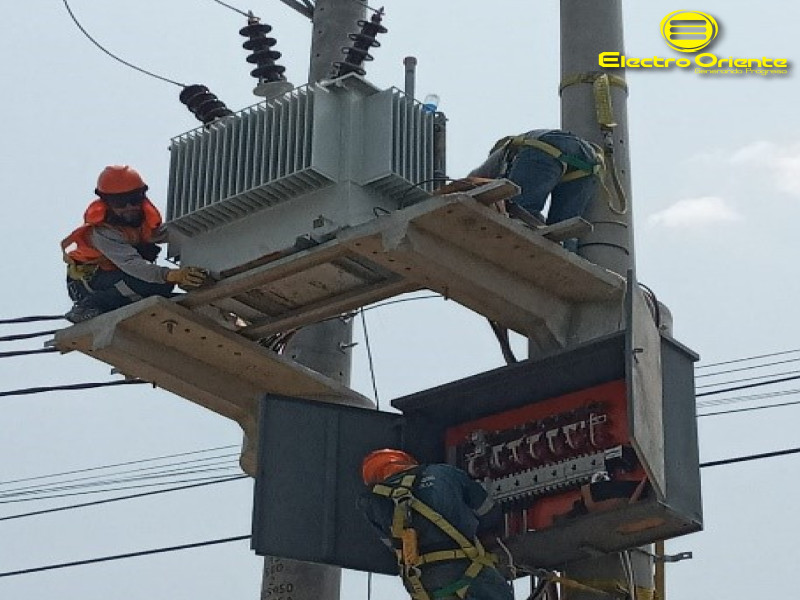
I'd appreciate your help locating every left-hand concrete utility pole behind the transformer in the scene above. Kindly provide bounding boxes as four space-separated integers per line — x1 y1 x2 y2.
261 0 366 600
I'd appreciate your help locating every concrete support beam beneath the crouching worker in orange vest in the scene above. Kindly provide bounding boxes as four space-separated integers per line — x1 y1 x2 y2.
52 296 372 475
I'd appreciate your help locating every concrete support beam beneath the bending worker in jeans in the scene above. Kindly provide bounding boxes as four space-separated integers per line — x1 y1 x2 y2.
338 193 624 351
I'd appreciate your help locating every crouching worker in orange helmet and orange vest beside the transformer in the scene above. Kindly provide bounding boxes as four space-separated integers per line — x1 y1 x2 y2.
61 165 206 323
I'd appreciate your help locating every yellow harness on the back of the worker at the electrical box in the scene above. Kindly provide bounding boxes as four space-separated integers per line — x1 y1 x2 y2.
372 469 494 600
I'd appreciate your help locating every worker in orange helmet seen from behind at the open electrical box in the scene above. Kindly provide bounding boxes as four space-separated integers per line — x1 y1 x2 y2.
359 448 514 600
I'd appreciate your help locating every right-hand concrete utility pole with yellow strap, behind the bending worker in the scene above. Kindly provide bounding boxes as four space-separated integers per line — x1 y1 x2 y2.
561 0 654 600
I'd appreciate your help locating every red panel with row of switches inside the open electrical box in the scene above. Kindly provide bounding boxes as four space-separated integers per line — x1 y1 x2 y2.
445 380 648 537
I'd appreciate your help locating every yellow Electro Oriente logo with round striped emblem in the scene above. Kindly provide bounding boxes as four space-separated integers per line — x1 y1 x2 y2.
598 10 789 76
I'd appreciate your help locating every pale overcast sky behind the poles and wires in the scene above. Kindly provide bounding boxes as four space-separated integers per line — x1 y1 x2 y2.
0 0 800 600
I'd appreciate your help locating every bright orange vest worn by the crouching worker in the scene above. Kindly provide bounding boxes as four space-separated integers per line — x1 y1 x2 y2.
61 198 161 271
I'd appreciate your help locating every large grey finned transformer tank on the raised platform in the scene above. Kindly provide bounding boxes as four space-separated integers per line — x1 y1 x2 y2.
167 74 436 273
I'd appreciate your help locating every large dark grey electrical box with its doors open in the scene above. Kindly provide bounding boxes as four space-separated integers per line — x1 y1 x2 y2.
253 288 702 573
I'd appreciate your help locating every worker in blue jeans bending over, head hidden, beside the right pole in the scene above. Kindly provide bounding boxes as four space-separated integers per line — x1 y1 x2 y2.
469 129 602 252
